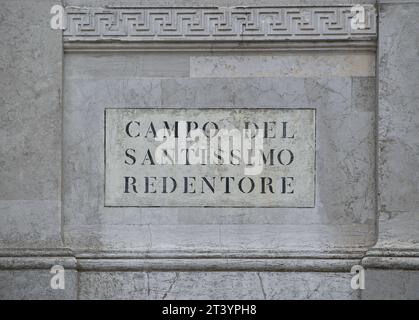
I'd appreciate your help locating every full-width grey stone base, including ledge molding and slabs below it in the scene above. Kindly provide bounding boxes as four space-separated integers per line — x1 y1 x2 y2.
0 248 419 300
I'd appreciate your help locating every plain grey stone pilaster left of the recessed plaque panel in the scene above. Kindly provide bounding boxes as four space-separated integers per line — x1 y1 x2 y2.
0 0 62 247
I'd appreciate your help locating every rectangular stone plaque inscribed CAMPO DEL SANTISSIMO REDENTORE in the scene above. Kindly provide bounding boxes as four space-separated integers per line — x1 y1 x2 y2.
105 108 316 207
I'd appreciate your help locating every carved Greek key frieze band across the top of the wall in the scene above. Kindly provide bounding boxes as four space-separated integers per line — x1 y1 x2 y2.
64 5 377 43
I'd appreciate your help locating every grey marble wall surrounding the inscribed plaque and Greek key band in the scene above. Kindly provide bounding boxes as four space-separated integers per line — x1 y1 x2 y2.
0 0 419 299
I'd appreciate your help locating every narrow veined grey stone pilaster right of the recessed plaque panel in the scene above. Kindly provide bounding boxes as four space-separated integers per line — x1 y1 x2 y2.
377 3 419 248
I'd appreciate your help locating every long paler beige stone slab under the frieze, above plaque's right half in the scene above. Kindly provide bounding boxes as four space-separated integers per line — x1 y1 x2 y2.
190 52 375 78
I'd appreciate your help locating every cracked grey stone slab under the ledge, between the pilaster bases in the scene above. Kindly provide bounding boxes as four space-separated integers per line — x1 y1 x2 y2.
80 272 359 300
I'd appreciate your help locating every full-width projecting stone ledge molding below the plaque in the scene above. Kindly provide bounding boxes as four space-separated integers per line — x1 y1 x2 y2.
0 248 419 272
